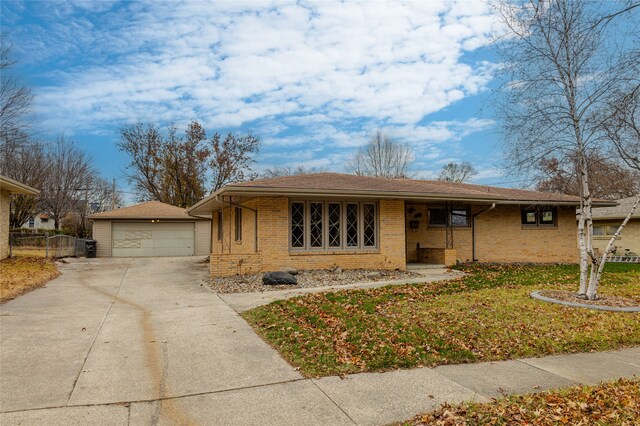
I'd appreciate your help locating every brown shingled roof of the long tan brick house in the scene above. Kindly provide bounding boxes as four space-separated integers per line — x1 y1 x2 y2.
188 173 612 214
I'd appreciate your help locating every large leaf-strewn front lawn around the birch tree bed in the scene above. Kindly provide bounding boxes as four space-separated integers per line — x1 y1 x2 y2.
244 264 640 376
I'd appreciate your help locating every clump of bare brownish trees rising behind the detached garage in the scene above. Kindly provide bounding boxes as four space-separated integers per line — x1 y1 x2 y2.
118 121 260 203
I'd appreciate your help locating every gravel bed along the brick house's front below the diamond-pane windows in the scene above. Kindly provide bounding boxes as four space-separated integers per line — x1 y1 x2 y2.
210 269 420 293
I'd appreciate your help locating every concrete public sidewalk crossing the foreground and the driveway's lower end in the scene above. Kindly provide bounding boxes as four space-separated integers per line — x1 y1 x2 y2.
5 347 640 425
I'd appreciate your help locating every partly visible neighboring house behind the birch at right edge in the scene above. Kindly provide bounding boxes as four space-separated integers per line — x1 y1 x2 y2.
593 197 640 256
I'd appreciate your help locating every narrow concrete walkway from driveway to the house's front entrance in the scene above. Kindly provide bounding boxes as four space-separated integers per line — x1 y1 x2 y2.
218 264 464 313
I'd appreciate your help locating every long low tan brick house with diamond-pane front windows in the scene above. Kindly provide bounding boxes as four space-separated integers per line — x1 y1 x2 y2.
188 173 614 276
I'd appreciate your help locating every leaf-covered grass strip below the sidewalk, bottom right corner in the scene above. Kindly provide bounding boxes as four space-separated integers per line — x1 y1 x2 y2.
403 379 640 426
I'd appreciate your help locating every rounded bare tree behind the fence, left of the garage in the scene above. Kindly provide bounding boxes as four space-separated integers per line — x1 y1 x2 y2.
40 136 96 229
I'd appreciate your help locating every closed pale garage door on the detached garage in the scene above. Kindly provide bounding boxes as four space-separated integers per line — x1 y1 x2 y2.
111 222 195 257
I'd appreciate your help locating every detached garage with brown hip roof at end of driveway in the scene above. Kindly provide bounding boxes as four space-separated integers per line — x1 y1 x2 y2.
89 201 211 257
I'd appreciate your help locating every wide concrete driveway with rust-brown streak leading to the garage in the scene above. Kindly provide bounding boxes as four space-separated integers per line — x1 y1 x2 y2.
0 258 348 425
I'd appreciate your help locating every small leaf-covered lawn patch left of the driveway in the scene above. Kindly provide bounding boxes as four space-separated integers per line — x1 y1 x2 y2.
0 258 60 303
